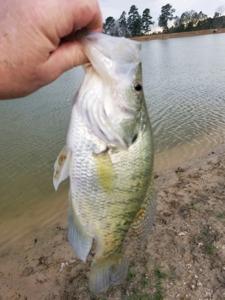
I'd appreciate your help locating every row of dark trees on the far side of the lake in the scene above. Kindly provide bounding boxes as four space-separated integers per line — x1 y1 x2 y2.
103 3 225 37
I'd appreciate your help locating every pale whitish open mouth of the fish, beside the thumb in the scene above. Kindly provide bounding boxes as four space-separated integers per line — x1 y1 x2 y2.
81 32 141 83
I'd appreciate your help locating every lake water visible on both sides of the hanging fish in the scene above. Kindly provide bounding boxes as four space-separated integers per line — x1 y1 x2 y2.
0 34 225 247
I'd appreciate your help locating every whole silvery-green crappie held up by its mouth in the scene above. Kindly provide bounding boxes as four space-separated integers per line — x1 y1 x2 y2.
53 33 154 293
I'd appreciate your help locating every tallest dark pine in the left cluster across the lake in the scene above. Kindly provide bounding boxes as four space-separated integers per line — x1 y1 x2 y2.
127 5 142 36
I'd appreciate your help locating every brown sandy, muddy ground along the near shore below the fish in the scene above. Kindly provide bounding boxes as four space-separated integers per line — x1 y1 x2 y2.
0 145 225 300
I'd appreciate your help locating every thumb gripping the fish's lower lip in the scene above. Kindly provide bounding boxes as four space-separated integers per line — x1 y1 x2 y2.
39 41 88 82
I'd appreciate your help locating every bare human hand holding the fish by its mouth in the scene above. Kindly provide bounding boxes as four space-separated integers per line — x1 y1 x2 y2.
0 0 102 99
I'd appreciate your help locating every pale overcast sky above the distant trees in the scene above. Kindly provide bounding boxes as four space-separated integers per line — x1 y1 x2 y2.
99 0 225 21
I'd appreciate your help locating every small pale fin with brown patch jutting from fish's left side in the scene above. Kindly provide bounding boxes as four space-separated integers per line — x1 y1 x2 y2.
53 146 71 191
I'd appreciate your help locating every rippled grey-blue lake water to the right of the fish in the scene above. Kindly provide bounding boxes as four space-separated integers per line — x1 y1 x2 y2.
143 34 225 159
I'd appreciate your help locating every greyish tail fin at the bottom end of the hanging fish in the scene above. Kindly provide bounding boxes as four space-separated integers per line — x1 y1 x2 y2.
89 255 128 294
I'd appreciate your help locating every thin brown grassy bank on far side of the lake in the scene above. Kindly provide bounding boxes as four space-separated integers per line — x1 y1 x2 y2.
133 28 225 41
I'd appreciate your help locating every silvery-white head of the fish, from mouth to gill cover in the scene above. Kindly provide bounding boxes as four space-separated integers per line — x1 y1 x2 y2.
76 33 141 148
